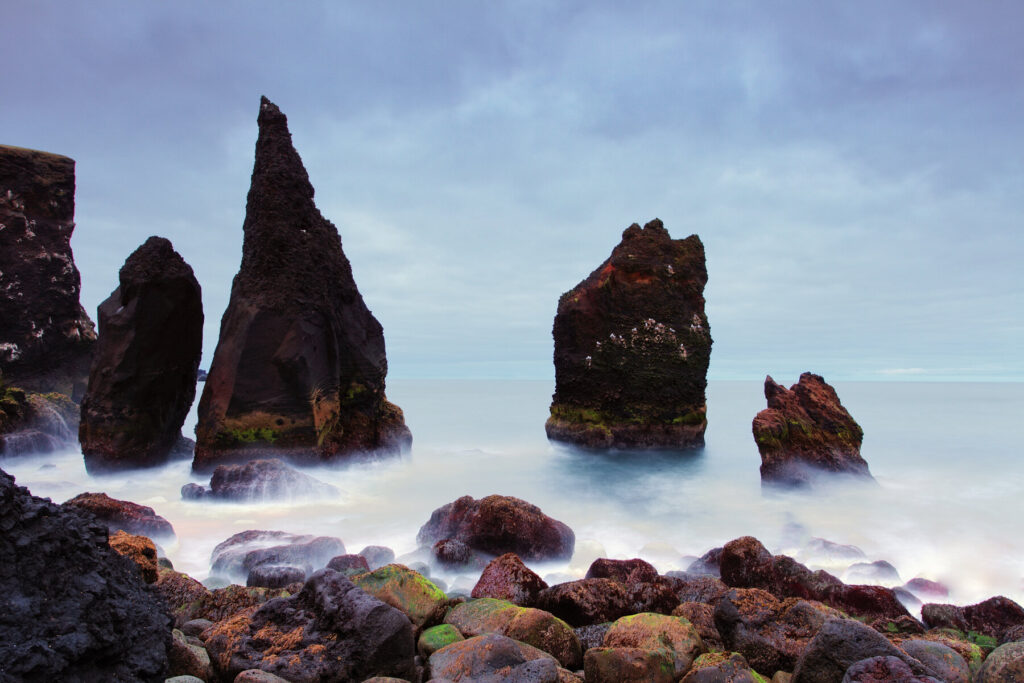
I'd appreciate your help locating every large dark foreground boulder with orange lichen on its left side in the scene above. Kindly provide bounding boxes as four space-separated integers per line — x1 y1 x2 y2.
205 569 416 681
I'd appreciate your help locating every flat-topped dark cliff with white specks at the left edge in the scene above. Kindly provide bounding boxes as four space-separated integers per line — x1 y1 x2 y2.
0 145 96 400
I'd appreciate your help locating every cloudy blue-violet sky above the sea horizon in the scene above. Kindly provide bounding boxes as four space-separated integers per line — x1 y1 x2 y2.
0 0 1024 383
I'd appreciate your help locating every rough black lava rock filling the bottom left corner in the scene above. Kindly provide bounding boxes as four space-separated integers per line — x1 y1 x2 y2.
0 470 171 681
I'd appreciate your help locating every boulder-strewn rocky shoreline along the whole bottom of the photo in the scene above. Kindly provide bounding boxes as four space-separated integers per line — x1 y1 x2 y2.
0 474 1024 683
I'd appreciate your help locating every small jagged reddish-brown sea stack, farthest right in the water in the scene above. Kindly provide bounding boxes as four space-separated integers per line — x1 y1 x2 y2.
753 373 871 486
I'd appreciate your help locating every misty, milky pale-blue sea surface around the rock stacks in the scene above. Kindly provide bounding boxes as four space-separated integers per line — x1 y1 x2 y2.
0 378 1024 604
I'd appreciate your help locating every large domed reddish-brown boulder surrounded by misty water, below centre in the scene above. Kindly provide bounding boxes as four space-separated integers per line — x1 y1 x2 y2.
417 496 575 560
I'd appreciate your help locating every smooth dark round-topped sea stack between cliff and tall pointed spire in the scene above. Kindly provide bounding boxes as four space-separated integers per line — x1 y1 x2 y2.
78 237 203 470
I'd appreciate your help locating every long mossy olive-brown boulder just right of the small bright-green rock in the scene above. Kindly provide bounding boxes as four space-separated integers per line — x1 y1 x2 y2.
444 598 583 669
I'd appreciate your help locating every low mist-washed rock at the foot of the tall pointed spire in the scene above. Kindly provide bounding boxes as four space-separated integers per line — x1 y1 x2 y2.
181 458 340 501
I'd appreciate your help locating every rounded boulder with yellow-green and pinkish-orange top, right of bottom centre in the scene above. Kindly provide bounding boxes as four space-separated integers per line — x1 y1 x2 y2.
604 612 706 679
